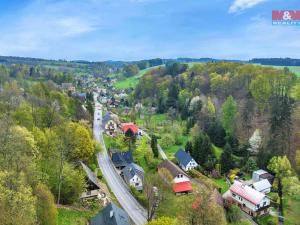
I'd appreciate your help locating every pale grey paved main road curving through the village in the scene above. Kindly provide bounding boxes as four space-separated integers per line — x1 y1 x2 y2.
94 94 147 225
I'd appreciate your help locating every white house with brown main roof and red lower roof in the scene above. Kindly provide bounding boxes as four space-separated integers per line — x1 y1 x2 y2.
157 159 193 195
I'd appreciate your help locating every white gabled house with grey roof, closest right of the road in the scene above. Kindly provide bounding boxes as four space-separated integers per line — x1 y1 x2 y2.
122 163 145 191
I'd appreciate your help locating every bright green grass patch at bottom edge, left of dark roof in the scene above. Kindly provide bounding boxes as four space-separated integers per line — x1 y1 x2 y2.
58 208 94 225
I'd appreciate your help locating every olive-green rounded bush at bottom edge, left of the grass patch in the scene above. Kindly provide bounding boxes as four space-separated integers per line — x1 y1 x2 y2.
34 184 58 225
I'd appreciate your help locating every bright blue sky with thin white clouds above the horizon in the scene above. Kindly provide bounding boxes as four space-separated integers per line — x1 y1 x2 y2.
0 0 300 61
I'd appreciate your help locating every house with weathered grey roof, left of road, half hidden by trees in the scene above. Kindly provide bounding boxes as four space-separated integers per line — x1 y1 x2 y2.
80 162 101 199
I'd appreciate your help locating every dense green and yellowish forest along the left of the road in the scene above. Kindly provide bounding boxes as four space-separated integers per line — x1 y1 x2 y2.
0 65 95 225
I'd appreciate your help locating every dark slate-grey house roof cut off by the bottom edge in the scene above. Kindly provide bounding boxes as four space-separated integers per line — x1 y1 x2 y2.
89 203 130 225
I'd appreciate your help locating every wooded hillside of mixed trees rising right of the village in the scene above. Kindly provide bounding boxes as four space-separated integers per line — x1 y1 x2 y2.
134 62 300 168
